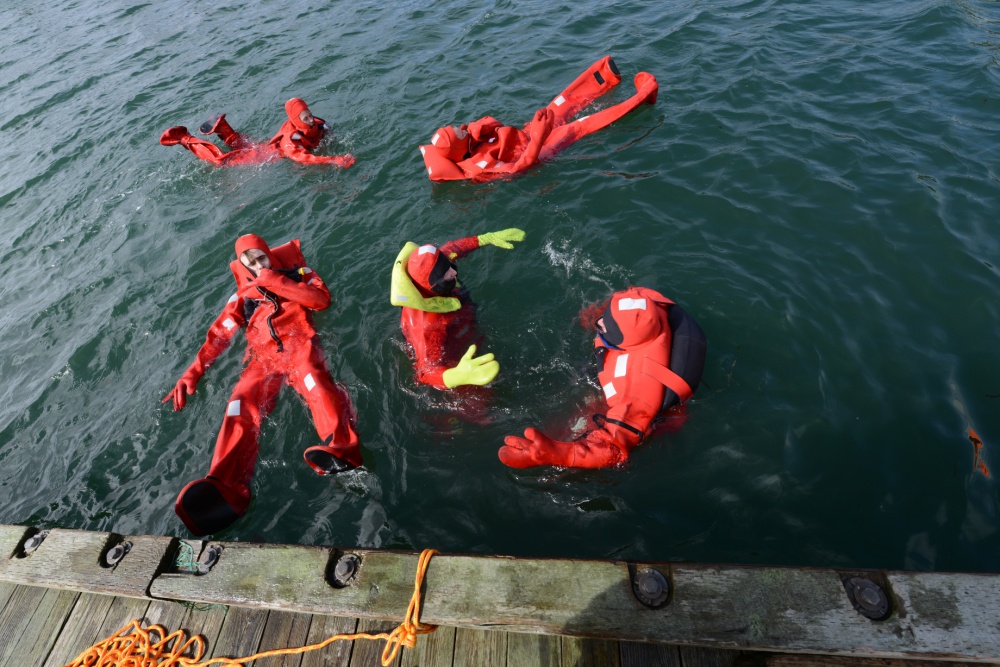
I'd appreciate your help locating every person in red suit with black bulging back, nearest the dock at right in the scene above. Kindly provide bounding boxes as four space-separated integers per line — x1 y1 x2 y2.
499 287 706 468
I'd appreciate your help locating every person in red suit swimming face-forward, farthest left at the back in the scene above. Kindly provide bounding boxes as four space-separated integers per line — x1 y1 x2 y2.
160 97 354 168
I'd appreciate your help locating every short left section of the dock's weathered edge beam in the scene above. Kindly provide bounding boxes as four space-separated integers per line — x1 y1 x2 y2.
0 529 174 597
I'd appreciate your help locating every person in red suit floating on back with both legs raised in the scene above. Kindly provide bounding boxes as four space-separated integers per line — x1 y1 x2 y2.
420 56 659 182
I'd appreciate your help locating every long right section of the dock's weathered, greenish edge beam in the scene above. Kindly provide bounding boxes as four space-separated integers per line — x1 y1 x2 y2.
151 544 1000 660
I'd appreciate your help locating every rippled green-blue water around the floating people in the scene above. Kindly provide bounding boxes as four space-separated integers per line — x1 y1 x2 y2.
0 0 1000 572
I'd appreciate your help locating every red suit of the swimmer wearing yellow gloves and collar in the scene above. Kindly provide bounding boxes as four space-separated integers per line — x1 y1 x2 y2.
400 236 488 389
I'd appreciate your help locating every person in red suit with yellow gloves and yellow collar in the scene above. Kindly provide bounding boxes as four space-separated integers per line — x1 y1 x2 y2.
390 229 524 389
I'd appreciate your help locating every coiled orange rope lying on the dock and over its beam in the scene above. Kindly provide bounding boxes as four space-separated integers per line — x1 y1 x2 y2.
65 549 440 667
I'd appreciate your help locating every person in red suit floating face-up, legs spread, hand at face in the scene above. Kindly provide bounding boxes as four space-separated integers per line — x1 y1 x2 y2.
163 234 362 535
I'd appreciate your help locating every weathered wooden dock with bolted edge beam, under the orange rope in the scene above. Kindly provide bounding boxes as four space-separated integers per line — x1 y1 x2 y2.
0 526 1000 667
